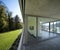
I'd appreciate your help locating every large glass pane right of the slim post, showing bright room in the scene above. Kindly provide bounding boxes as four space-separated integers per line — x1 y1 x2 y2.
38 18 60 40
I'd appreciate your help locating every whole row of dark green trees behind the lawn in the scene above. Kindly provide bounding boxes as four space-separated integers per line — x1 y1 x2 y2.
0 1 22 32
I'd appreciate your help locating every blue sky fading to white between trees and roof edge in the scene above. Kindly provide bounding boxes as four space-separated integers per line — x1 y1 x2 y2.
1 0 22 22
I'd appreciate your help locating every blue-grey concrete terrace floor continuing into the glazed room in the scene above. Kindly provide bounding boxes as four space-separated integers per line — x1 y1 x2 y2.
24 32 60 50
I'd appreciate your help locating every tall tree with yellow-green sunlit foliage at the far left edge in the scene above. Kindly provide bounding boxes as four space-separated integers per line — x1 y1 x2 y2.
0 5 8 32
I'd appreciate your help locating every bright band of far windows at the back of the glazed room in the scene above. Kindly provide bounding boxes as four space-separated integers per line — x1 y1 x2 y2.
42 21 60 33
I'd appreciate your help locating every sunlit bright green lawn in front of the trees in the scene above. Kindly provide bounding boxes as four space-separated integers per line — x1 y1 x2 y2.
0 30 22 50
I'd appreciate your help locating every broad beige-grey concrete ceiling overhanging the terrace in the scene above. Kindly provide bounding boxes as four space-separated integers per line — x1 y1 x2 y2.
25 0 60 19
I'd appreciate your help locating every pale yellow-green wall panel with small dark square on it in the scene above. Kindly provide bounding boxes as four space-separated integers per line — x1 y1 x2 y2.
28 17 36 36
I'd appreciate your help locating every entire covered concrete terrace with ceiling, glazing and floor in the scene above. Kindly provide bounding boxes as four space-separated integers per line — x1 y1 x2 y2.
18 0 60 50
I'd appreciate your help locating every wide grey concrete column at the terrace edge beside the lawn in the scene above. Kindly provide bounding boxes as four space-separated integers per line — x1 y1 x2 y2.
23 16 28 43
